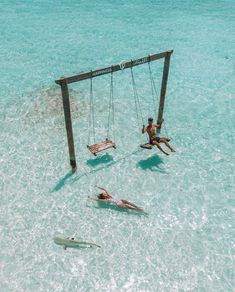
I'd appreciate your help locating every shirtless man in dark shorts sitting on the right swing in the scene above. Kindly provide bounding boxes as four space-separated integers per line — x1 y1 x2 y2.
142 118 175 155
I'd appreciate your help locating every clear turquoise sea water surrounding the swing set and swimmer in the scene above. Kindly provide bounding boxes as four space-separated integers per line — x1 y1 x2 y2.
0 0 235 291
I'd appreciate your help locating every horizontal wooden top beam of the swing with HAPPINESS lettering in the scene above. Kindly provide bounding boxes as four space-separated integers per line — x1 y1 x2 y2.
55 50 173 84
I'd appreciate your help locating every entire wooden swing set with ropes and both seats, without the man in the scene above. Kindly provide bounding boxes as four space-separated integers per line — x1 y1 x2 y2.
55 50 173 171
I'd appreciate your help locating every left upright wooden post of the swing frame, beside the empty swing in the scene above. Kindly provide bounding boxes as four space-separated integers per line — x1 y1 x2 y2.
60 79 77 171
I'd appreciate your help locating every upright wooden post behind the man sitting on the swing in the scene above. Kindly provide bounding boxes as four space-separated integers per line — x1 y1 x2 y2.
157 52 171 132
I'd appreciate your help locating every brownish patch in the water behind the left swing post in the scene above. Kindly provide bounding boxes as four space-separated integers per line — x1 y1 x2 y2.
4 86 87 126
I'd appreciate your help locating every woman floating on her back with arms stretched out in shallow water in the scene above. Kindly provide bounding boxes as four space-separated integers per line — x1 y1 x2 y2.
88 186 145 213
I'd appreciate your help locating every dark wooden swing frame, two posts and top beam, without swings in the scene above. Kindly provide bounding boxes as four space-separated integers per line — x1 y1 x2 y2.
55 50 173 171
